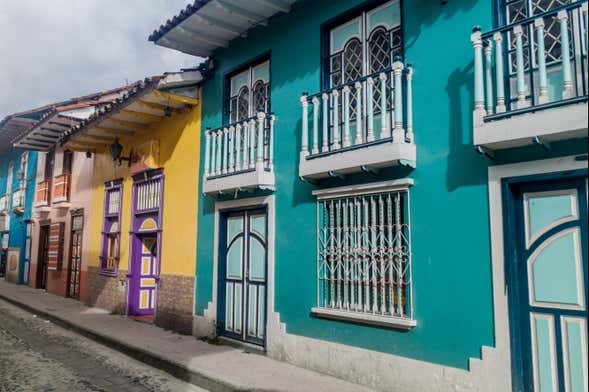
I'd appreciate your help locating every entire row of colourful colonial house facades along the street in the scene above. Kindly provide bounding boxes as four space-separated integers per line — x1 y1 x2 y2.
0 0 589 391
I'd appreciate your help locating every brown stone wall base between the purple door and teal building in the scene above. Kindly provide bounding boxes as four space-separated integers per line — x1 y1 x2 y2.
155 275 194 335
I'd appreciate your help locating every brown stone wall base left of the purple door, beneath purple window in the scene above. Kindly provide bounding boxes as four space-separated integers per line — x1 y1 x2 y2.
86 267 127 314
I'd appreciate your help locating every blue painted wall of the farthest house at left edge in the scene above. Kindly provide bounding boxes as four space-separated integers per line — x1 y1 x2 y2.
0 148 37 283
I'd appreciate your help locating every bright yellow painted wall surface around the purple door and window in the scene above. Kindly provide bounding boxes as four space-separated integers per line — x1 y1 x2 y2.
88 104 201 276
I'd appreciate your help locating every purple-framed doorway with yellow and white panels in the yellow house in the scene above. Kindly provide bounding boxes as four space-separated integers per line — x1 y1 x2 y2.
127 169 164 316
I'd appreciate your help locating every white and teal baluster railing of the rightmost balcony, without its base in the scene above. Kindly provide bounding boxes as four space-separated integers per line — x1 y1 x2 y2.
471 1 587 127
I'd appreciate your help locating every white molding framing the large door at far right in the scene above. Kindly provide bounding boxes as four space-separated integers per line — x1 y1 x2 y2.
489 156 587 391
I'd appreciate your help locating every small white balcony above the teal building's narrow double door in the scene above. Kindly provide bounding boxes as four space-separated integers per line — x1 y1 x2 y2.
203 112 275 194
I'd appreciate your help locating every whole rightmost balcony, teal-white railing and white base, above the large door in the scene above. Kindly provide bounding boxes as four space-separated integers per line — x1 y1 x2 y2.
471 1 587 150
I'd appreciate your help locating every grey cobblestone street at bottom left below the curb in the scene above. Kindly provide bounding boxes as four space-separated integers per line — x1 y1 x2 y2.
0 300 204 392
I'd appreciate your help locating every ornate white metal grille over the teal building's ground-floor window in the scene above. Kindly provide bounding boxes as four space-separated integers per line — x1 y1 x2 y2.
318 190 411 318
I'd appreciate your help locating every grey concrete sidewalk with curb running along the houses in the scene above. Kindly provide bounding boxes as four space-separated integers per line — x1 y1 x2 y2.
0 280 369 392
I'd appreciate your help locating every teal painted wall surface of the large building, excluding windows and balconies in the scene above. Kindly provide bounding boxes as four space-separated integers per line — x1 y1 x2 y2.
196 0 584 368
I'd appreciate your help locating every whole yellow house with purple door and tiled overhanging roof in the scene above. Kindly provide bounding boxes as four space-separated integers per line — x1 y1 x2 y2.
64 74 201 333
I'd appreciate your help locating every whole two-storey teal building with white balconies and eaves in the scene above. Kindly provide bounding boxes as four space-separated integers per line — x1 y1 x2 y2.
150 0 587 391
